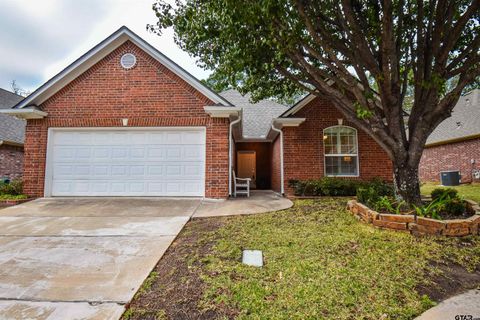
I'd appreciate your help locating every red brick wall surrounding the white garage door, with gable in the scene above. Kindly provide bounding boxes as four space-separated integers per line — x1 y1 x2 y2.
24 42 228 198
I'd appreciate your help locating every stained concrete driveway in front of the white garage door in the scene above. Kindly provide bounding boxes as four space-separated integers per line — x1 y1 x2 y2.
0 198 201 320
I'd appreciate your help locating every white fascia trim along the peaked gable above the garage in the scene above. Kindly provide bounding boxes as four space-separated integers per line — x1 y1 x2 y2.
14 26 231 109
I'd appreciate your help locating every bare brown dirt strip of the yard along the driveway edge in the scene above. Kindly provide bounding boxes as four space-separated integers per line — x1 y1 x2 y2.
122 217 237 320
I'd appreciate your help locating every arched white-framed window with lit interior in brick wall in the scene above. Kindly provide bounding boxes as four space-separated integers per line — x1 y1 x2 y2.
323 126 358 177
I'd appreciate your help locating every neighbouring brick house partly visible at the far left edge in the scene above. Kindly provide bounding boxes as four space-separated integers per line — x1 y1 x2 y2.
0 88 26 180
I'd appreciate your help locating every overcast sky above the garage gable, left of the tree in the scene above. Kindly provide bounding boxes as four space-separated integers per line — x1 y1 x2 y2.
0 0 209 91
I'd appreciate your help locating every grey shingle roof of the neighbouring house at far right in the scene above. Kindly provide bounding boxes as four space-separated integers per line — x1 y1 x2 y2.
427 89 480 145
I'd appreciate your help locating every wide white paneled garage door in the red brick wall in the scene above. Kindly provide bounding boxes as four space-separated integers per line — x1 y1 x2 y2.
46 128 205 196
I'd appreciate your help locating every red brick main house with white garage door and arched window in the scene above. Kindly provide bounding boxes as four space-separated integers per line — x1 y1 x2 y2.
2 27 392 198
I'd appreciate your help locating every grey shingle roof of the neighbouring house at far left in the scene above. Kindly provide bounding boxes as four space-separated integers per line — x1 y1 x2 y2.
0 88 26 144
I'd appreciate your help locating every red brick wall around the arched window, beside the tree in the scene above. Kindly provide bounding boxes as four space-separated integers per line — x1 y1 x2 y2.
283 97 393 195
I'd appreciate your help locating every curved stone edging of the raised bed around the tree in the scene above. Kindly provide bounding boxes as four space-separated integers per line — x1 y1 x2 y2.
347 200 480 237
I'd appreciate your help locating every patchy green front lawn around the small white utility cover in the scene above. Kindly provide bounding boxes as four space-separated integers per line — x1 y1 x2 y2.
124 198 480 320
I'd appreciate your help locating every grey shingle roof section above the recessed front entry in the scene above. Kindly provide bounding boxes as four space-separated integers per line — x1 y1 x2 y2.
220 89 288 139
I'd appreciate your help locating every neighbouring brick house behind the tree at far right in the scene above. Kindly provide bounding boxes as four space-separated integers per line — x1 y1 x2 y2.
419 89 480 183
